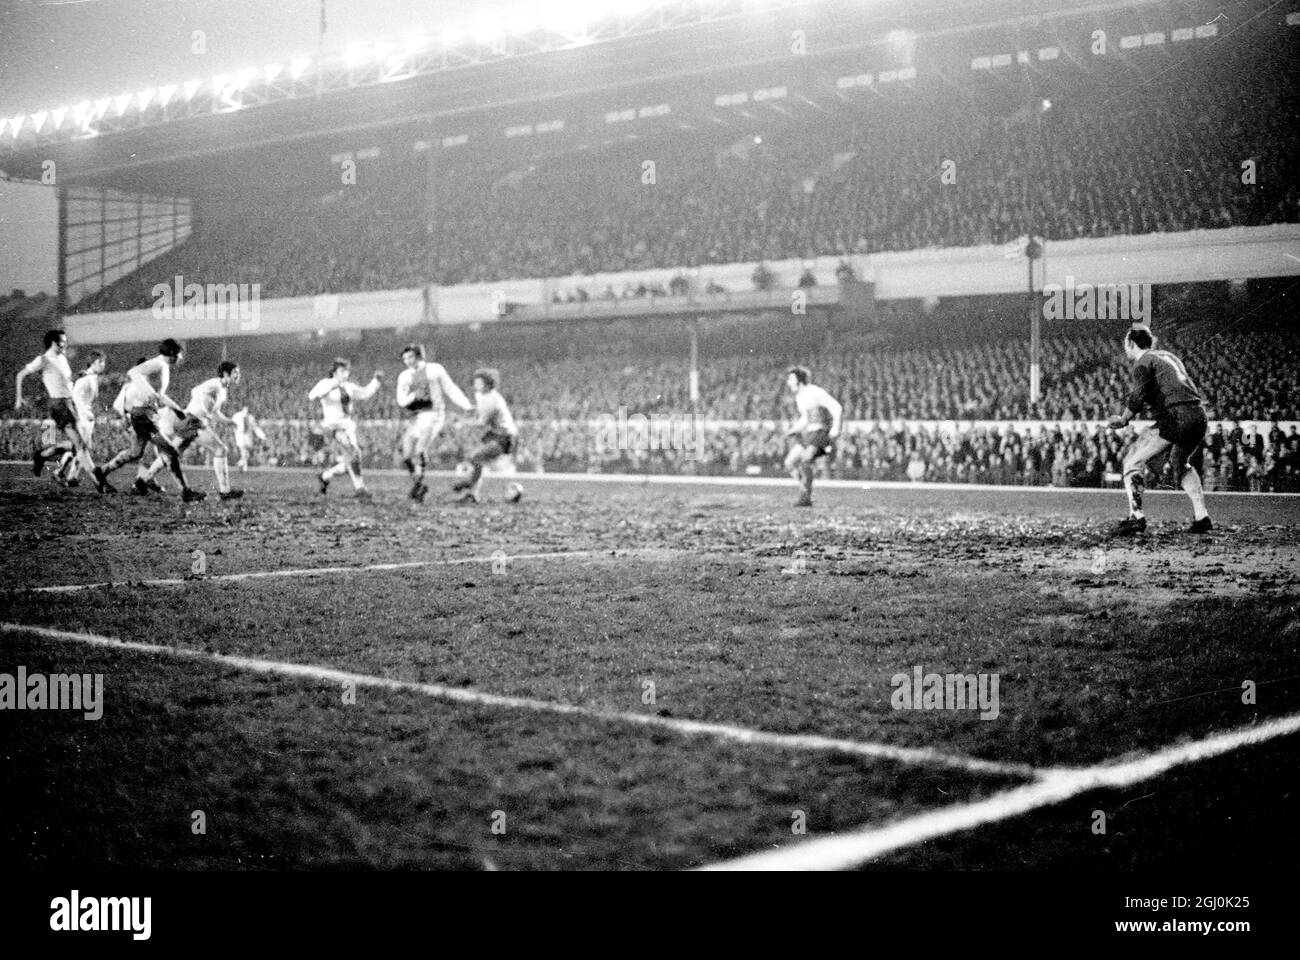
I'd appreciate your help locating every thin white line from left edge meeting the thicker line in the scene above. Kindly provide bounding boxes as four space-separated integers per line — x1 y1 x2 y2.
0 623 1037 777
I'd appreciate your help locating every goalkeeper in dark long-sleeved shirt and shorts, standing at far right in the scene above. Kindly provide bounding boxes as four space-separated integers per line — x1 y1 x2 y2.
1110 328 1214 536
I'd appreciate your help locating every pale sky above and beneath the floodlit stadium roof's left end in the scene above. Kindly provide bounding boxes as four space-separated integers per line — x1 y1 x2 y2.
0 0 517 293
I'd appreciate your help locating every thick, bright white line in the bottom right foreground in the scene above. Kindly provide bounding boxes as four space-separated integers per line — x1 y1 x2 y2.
701 713 1300 870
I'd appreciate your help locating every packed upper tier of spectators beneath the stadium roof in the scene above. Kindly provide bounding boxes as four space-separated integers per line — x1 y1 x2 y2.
77 27 1300 311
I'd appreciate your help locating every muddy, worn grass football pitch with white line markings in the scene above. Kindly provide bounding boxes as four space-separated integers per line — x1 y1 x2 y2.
0 466 1300 870
